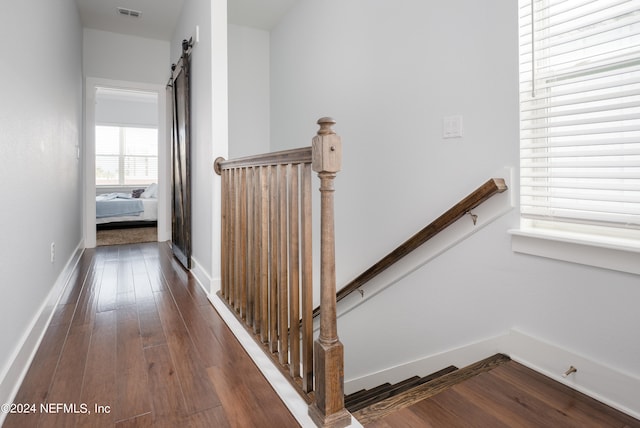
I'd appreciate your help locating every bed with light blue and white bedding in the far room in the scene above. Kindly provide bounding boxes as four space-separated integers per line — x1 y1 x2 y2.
96 184 158 229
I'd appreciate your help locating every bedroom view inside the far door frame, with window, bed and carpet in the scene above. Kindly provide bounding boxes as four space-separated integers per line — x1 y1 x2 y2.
95 87 159 246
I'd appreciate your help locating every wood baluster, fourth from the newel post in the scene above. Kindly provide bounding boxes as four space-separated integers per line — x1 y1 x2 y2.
269 167 279 353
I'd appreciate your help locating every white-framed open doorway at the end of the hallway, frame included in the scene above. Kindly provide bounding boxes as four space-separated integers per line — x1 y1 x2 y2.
84 78 171 248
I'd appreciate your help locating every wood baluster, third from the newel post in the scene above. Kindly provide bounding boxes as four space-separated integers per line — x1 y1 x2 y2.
278 165 289 365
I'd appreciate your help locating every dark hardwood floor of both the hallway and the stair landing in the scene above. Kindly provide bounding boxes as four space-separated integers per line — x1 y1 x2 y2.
3 243 640 428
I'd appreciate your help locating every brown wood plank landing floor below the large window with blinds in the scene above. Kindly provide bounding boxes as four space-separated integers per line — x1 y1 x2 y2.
365 361 640 428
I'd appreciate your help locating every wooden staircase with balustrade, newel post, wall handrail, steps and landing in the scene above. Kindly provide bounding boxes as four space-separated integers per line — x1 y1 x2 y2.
214 118 640 428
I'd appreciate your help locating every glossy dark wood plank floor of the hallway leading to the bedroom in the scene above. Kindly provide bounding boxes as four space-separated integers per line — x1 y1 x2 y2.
3 243 299 428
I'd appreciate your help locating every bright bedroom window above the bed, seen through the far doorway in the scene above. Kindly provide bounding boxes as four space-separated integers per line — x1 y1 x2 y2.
96 126 158 186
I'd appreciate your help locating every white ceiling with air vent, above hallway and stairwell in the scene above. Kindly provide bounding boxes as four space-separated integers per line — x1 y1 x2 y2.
76 0 297 40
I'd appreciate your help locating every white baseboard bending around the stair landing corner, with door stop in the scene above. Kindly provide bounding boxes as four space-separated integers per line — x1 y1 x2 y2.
344 329 640 419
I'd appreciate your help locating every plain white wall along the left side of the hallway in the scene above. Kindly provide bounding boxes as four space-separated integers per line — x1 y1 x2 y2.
0 0 82 410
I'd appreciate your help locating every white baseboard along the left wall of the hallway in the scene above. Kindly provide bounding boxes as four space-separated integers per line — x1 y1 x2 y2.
0 241 84 426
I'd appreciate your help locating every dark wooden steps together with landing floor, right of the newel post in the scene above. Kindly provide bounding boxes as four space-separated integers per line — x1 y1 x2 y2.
345 354 640 428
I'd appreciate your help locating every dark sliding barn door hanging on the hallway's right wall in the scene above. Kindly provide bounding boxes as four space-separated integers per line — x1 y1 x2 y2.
171 52 191 269
